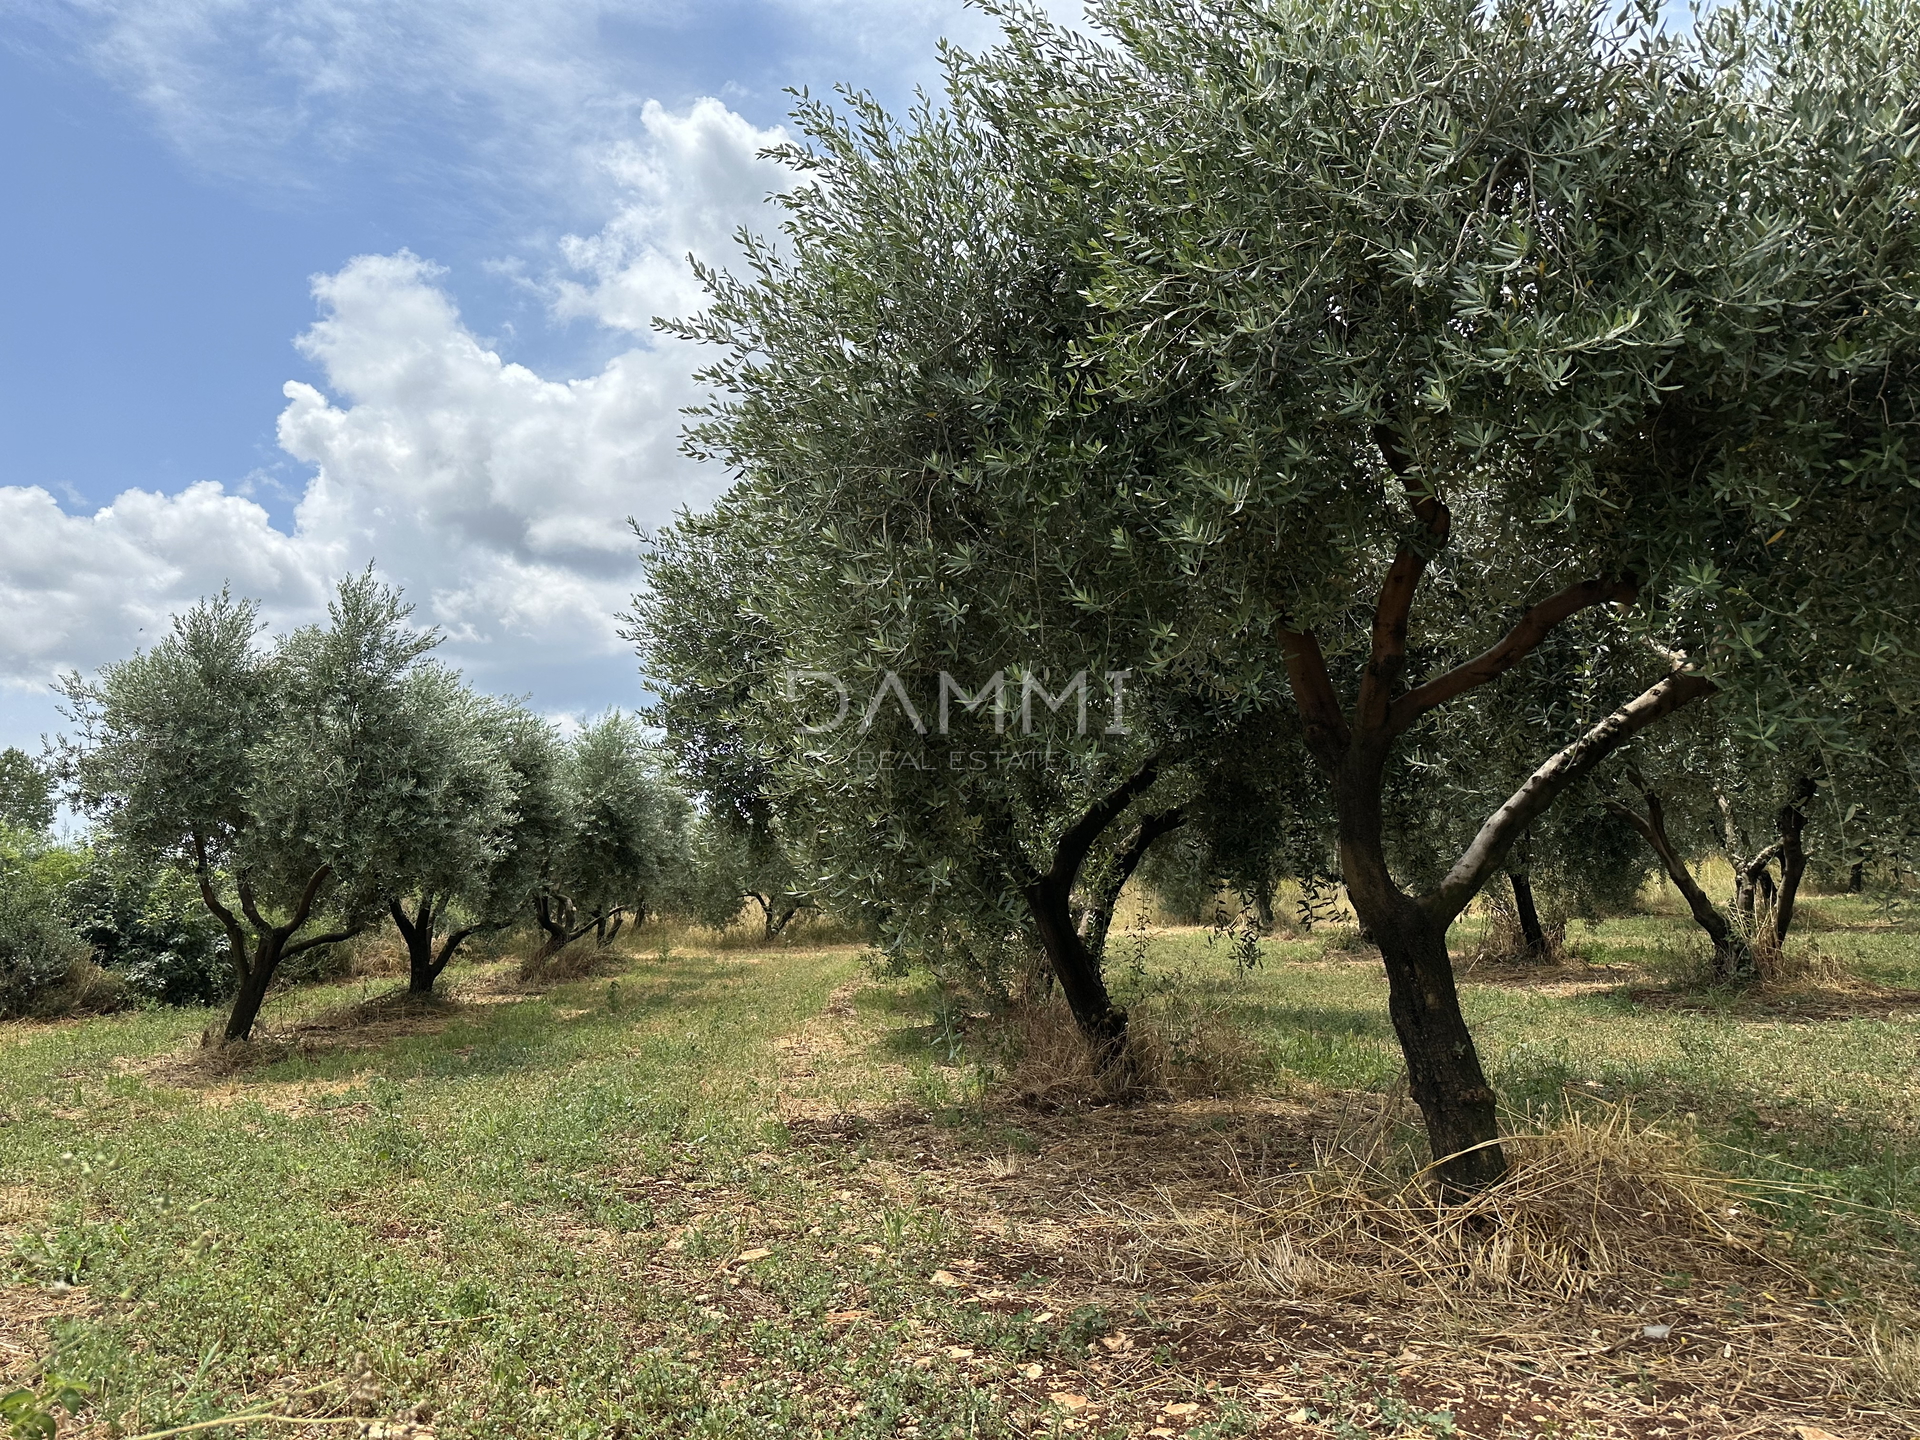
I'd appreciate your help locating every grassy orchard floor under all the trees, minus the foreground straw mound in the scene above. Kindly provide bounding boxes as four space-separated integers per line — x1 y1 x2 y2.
0 897 1920 1440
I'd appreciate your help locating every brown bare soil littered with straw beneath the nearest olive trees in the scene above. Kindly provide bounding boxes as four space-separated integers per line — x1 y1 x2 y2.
756 990 1920 1440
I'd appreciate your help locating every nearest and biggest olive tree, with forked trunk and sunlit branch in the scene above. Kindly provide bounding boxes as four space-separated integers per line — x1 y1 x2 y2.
983 0 1920 1185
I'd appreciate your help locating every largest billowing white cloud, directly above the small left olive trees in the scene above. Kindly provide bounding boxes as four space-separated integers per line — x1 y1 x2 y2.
280 252 716 672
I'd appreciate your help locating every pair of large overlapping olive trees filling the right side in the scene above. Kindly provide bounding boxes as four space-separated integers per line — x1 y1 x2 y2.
636 0 1920 1187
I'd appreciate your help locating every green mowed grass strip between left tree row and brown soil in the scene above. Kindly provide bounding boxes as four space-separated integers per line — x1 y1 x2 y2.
0 952 1021 1436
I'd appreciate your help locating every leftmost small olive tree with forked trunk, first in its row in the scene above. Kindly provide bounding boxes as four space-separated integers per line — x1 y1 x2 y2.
61 572 449 1041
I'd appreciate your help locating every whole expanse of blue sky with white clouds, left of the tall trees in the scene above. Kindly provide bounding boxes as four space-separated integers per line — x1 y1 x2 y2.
0 0 1052 749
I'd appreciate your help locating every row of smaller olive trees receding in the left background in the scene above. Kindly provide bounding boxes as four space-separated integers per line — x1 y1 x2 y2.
60 572 685 1041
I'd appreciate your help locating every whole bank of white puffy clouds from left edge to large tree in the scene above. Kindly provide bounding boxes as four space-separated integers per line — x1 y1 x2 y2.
0 100 780 728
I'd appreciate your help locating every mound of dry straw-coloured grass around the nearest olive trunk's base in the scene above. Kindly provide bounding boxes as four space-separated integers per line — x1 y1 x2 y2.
1121 1106 1780 1302
